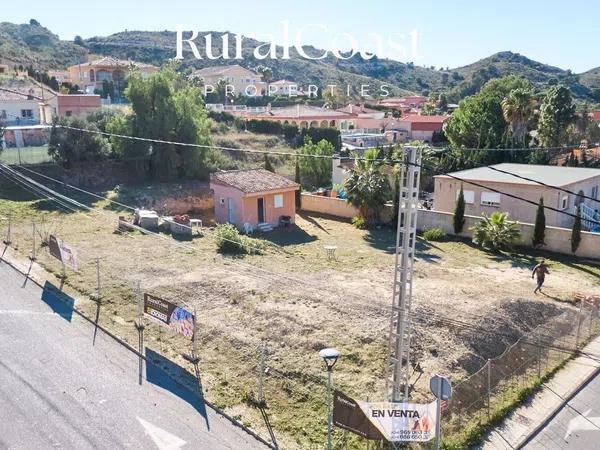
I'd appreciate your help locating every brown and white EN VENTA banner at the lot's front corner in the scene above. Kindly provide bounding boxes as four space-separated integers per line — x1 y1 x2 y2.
333 391 436 442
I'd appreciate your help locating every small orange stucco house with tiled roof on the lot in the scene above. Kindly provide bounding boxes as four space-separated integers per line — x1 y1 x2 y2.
210 169 300 229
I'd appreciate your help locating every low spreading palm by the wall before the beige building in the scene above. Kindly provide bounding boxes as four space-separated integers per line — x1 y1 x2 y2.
471 212 521 251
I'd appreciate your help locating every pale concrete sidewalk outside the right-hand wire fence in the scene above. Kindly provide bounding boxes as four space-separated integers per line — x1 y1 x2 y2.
480 337 600 450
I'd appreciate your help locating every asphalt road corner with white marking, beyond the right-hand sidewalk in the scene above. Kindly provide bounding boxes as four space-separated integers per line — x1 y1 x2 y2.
523 375 600 450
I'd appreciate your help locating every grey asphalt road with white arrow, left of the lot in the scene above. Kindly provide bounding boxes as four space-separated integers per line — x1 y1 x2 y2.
0 262 268 450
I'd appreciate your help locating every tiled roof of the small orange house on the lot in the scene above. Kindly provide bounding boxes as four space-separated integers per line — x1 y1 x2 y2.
210 169 300 194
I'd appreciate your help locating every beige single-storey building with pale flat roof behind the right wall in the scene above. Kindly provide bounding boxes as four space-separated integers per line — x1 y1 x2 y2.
433 163 600 230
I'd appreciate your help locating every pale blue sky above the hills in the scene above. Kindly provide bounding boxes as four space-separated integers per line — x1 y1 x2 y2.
1 0 600 72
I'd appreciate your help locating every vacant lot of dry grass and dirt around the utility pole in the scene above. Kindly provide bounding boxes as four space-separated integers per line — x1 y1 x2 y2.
0 180 600 448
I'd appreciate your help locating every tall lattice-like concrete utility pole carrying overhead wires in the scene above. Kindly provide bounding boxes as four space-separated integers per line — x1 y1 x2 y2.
386 147 421 402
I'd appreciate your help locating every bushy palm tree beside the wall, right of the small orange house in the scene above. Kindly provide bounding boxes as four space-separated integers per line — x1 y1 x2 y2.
345 148 391 223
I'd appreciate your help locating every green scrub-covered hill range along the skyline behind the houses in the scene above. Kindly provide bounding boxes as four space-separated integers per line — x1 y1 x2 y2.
0 22 600 103
